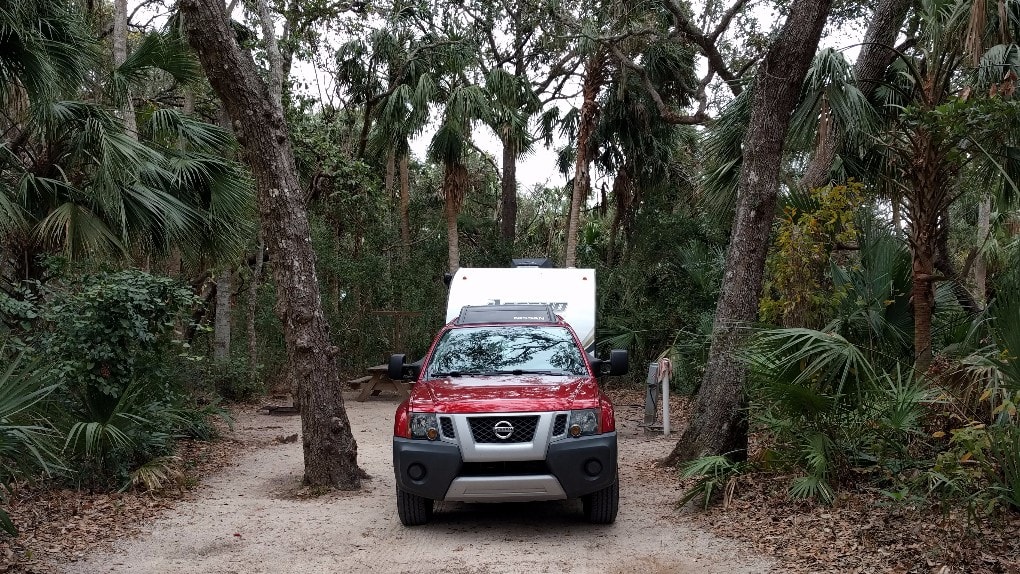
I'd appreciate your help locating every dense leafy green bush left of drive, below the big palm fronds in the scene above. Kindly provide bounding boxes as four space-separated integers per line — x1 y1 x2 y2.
0 271 221 487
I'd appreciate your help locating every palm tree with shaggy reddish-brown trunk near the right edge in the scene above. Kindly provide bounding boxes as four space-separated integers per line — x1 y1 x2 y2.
883 2 1020 372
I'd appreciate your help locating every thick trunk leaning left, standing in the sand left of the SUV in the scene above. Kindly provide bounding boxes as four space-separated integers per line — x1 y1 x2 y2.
181 0 365 489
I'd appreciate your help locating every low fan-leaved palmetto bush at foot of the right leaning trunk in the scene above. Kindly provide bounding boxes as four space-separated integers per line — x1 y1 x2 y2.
744 328 935 502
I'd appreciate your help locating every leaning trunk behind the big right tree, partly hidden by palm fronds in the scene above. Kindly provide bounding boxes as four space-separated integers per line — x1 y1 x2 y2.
801 0 913 190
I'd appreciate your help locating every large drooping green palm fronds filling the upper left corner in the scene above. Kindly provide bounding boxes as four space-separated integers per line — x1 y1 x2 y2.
0 0 252 277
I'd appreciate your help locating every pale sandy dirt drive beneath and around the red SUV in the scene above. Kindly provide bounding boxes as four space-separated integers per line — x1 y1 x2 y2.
62 396 769 574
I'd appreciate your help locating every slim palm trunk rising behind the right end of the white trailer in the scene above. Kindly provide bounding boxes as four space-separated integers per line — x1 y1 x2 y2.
563 52 606 267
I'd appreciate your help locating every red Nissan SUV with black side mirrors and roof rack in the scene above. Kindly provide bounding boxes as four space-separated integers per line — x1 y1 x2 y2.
390 305 627 526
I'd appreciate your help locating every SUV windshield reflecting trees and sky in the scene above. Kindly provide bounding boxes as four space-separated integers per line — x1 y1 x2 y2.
426 325 588 378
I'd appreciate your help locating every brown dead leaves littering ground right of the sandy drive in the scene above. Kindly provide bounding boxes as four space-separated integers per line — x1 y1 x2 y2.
612 389 1020 574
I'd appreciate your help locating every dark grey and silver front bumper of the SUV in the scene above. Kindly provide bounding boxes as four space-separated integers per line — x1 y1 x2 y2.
393 432 617 503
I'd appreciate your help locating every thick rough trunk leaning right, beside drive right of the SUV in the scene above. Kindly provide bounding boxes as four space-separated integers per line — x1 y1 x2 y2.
663 0 830 465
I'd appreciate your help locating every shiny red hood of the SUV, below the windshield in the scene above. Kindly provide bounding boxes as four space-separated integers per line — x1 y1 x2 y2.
411 375 599 413
